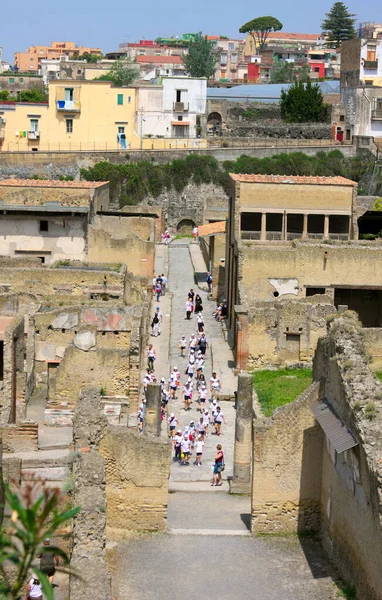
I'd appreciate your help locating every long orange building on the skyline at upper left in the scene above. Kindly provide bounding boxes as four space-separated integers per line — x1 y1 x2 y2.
15 42 102 72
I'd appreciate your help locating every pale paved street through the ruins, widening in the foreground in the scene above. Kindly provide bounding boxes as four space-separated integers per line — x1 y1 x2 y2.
109 239 336 600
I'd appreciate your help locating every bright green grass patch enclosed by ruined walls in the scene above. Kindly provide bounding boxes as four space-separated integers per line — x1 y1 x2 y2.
253 369 312 417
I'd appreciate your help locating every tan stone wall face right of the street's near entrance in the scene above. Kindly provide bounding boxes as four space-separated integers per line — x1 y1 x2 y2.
251 383 322 533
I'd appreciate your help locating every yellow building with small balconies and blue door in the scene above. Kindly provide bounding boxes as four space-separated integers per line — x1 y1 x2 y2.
0 79 206 151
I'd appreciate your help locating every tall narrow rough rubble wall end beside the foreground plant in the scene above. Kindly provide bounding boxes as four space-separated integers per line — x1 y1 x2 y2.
69 389 111 600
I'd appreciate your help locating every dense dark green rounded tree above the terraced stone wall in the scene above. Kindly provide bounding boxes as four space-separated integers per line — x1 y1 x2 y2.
280 80 329 123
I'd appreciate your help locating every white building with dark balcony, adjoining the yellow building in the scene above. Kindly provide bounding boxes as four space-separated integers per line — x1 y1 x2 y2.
136 77 207 139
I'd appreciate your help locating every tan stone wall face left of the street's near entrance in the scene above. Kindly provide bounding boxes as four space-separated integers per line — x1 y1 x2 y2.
100 427 171 540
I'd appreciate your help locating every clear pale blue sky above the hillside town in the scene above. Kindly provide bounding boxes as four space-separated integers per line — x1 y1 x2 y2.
0 0 382 61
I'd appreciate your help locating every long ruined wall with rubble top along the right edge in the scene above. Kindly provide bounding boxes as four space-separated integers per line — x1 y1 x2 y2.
314 317 382 600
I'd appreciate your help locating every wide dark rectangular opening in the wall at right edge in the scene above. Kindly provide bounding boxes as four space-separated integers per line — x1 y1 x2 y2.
334 288 382 327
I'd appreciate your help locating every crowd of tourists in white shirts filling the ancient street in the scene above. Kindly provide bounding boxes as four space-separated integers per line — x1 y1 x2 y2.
143 273 226 486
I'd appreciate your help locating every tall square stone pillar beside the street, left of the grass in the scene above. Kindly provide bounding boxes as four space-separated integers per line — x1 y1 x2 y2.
230 373 253 494
